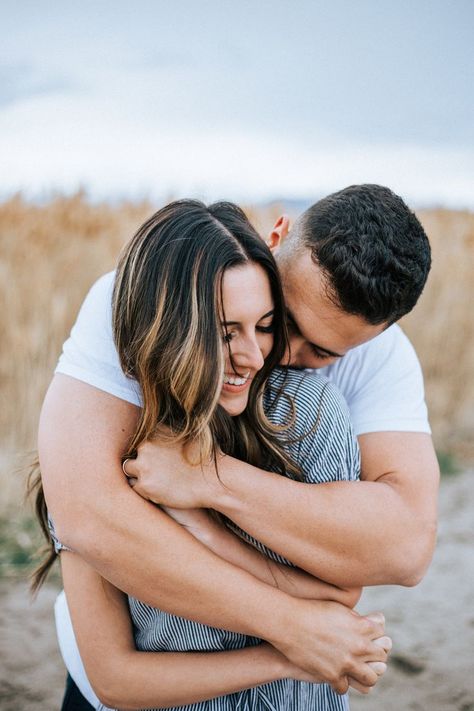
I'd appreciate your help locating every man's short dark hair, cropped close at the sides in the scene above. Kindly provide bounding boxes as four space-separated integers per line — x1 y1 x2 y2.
290 185 431 325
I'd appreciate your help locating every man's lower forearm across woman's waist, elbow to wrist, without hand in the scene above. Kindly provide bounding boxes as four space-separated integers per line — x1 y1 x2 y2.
57 482 288 636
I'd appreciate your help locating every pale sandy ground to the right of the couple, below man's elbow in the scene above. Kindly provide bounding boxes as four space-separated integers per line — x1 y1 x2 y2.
351 471 474 711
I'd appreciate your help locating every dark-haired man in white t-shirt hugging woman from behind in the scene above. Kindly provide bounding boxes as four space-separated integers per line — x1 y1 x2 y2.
39 186 437 691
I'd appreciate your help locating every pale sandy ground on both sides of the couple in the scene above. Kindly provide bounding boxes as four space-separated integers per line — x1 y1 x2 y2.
0 471 474 711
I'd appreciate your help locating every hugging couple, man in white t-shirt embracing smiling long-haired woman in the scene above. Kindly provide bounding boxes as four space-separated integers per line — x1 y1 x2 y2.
36 185 438 711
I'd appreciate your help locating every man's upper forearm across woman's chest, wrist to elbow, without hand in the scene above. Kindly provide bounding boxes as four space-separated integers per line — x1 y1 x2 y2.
204 457 434 587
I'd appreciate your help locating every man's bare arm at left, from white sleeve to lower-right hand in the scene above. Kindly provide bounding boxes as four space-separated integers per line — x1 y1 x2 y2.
39 375 386 691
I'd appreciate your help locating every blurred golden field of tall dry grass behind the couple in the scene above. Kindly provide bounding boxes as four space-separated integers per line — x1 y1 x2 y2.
0 193 474 516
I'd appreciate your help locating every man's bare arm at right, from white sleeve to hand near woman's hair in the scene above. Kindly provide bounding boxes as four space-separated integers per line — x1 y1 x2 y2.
128 432 439 587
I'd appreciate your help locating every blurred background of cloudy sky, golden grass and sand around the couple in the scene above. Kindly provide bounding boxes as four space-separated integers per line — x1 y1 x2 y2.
0 0 474 711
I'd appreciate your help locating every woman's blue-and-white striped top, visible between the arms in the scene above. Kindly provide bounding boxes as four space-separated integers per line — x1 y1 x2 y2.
52 369 360 711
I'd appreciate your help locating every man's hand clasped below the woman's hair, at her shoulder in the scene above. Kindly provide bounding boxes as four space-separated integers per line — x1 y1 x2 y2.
125 439 220 509
